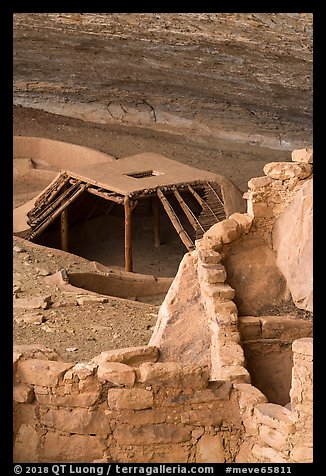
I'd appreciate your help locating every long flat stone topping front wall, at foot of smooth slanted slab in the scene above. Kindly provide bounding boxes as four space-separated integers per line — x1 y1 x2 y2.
139 362 209 388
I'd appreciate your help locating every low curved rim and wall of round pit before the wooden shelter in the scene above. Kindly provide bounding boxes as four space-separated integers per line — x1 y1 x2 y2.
46 270 174 305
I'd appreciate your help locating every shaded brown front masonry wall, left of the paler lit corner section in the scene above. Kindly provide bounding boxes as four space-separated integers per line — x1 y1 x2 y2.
14 346 243 462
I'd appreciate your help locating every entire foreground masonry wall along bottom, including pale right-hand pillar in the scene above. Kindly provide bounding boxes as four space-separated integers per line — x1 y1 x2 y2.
13 338 312 463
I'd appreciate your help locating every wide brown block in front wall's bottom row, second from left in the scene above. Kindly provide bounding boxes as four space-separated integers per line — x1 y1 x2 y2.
39 432 105 463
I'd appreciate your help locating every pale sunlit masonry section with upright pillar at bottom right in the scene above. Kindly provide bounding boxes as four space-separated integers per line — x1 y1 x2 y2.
236 338 313 463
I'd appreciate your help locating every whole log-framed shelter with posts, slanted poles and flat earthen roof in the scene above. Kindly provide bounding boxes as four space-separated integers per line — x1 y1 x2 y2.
27 153 226 271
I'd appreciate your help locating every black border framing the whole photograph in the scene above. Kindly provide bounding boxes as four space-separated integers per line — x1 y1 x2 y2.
5 1 320 474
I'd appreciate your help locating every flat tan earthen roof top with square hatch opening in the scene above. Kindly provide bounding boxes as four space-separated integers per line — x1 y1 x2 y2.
66 152 216 195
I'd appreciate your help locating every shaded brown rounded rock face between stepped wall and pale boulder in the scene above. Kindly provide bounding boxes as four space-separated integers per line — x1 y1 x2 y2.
223 237 286 315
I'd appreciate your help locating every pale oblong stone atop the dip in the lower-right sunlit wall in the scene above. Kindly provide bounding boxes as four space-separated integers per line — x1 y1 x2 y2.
254 403 296 434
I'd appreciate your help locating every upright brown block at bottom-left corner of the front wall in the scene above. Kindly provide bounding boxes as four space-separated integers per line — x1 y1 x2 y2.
13 425 39 463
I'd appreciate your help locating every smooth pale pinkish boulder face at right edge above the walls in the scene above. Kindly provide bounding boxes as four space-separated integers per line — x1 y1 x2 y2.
273 179 313 311
